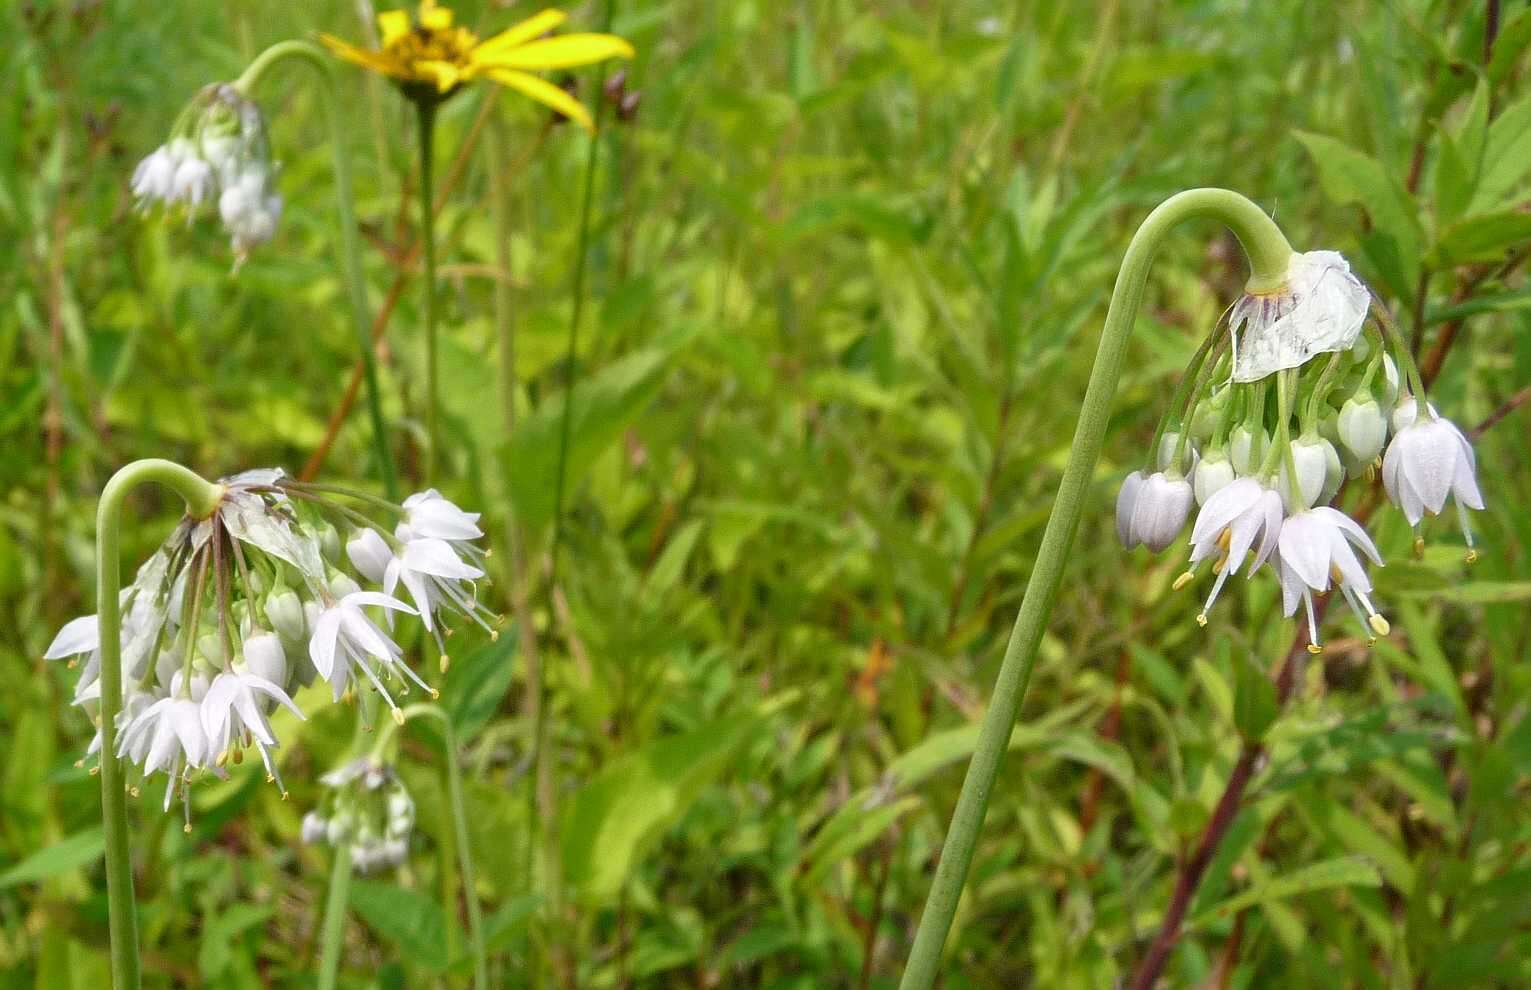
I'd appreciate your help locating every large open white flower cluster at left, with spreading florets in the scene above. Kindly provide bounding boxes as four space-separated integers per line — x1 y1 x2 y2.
46 468 498 817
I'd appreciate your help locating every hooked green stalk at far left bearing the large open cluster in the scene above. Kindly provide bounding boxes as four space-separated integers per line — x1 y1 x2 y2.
96 459 224 990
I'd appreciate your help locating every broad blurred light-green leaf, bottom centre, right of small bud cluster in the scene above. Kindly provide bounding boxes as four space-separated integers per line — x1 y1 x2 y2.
563 716 759 904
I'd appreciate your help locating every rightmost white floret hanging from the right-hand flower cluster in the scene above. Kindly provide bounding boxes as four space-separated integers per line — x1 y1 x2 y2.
1382 398 1484 562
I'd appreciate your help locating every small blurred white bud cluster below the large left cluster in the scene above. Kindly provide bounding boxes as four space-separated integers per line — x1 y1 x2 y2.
302 756 415 874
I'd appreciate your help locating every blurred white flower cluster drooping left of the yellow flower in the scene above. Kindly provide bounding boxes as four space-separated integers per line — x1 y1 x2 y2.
132 83 282 263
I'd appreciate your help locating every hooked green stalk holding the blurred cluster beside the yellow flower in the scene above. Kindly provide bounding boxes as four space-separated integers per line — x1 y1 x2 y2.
234 41 398 502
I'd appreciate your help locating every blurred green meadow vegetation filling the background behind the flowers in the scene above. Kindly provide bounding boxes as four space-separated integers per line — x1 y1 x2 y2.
0 0 1531 990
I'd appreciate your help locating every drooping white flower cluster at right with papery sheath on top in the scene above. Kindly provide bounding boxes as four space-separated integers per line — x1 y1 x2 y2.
1116 251 1484 653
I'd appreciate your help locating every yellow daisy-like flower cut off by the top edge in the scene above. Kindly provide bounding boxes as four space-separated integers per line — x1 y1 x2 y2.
320 0 632 130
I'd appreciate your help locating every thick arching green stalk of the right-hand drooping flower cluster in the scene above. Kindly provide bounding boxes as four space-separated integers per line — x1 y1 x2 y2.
899 188 1292 990
